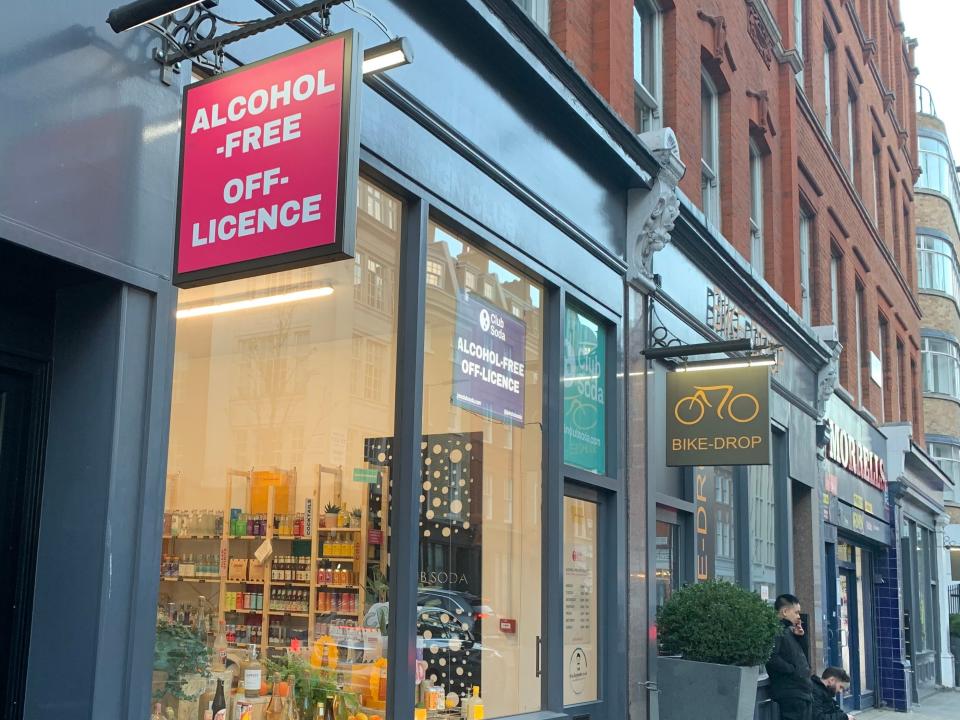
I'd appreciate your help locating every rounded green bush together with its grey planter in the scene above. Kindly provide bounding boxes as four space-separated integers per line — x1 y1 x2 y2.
657 580 780 720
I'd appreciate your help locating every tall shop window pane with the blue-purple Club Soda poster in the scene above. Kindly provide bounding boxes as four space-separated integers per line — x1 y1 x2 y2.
417 224 543 717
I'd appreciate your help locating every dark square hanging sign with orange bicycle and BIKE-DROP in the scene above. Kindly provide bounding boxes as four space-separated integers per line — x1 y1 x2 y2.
665 366 770 467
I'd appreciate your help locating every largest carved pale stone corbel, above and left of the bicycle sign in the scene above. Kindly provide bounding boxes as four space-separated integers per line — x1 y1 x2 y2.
627 128 687 290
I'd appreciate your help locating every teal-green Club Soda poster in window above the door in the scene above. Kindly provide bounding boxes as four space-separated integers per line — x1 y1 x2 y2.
563 308 607 475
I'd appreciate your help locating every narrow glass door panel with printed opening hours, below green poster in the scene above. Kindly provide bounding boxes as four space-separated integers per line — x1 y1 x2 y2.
563 497 597 705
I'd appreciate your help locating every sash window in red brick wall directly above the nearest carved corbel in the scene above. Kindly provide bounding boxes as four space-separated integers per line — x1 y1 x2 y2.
633 0 663 132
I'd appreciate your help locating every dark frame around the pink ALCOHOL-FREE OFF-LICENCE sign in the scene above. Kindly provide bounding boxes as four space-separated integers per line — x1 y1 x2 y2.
173 30 362 288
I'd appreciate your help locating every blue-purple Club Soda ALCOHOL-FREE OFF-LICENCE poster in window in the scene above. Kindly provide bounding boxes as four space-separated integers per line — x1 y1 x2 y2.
453 292 527 424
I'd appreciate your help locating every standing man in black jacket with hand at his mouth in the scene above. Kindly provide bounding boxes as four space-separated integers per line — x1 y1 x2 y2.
767 594 813 720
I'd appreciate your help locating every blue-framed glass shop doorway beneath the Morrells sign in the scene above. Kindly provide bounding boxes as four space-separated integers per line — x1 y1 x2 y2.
835 542 876 710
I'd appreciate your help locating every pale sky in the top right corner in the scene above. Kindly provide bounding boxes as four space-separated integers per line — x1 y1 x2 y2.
900 0 960 150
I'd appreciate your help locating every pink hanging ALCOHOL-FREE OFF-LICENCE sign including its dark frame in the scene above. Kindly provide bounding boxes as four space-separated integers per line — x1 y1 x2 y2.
174 31 361 287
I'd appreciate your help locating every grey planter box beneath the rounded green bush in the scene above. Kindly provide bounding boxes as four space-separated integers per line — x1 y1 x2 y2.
657 657 760 720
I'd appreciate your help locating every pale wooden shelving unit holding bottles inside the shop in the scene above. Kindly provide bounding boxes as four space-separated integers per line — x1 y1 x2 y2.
161 466 376 654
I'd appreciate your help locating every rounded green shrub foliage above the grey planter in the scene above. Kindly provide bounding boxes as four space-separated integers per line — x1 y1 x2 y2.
657 580 780 667
